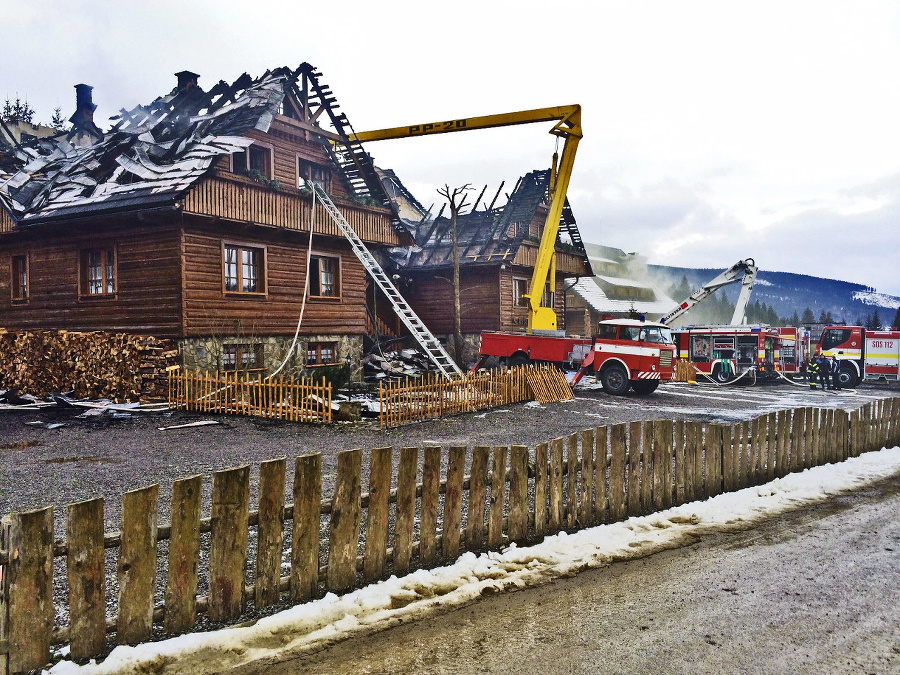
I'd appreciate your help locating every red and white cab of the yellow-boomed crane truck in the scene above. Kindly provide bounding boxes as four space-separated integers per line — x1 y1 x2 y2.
572 319 675 396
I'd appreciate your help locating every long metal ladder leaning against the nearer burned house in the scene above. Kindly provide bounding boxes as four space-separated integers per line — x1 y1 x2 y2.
309 181 462 378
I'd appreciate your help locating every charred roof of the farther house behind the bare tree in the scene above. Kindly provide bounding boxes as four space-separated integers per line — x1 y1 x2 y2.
391 169 587 269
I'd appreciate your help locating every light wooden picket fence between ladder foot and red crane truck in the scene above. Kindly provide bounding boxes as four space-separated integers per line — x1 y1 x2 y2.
378 364 572 429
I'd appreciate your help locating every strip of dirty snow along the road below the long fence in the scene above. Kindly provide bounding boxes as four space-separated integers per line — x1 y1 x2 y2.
49 448 900 675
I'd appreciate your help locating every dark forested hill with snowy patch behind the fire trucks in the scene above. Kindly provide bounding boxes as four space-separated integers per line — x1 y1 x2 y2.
647 265 900 325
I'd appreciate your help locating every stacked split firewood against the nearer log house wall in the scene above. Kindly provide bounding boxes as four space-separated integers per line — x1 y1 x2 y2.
0 329 178 403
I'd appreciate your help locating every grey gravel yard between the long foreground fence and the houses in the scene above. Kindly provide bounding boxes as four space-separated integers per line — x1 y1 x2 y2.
0 374 900 656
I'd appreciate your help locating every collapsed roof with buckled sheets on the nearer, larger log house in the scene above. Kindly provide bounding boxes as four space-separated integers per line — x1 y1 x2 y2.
0 63 399 227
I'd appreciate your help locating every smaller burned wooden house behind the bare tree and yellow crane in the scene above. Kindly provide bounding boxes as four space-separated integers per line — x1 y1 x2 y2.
383 170 591 361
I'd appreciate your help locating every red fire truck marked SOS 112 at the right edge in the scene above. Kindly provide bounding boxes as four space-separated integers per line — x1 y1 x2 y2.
818 326 900 387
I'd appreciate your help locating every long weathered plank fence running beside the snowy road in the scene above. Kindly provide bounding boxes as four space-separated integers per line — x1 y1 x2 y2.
0 398 900 673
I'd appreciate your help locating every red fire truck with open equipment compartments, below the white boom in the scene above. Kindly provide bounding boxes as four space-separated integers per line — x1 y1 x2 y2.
674 325 779 383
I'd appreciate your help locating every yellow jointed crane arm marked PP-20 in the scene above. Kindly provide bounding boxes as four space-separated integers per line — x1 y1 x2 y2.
350 104 582 333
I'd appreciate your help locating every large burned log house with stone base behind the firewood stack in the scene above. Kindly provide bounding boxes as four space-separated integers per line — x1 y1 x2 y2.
0 63 410 372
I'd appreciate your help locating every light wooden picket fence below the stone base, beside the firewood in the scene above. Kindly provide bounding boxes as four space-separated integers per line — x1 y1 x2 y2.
169 371 332 424
